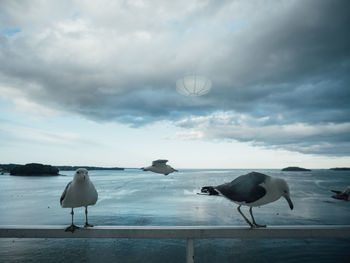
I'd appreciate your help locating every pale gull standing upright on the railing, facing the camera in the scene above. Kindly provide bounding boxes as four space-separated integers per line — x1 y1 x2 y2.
60 168 98 233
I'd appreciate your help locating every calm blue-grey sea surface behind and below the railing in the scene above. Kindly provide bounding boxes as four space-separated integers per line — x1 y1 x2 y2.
0 169 350 263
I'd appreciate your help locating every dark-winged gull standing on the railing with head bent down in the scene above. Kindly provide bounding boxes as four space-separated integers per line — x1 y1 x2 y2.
201 172 294 228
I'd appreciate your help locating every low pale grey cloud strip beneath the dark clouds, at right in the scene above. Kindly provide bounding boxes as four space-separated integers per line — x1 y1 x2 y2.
177 112 350 156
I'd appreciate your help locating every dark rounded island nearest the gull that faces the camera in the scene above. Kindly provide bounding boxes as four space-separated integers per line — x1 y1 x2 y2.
10 163 59 176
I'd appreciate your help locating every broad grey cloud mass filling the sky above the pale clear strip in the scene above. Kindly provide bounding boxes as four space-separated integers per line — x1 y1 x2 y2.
0 0 350 155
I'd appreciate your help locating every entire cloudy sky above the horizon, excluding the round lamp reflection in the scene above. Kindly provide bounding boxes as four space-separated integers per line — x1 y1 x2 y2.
0 0 350 168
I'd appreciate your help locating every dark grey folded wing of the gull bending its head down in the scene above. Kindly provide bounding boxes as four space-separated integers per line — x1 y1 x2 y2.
215 172 267 203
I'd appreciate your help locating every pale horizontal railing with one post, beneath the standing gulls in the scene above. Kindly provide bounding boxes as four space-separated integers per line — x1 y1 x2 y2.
0 225 350 262
